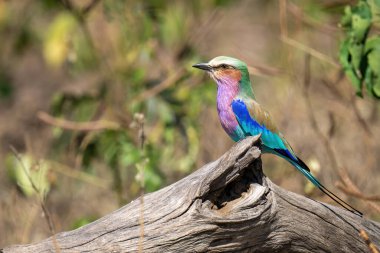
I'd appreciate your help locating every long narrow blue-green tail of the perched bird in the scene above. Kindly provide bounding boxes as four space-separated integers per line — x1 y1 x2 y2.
286 157 363 217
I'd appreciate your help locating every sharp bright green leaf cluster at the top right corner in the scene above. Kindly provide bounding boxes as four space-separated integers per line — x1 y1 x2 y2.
339 0 380 98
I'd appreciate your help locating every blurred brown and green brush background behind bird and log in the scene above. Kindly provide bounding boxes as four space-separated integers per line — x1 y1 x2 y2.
0 0 380 246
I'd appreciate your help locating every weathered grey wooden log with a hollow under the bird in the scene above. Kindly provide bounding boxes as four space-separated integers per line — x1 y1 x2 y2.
2 137 380 253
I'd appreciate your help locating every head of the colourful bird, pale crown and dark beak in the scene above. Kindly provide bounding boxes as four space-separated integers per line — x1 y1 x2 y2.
193 56 252 94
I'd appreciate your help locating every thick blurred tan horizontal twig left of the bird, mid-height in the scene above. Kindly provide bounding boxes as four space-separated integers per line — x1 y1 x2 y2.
37 111 121 131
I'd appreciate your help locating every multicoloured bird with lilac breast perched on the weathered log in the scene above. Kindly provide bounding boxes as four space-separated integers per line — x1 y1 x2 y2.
192 56 363 216
